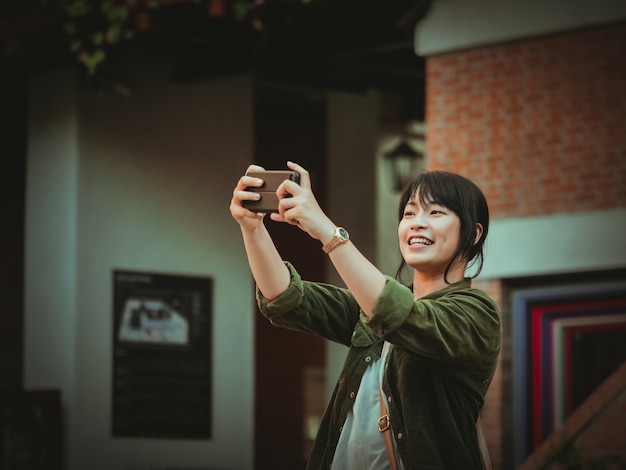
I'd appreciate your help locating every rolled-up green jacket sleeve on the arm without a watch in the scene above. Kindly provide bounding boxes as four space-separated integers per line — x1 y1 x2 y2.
256 262 360 346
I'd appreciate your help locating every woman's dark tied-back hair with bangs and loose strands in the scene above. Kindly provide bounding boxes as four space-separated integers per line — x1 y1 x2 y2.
396 171 489 282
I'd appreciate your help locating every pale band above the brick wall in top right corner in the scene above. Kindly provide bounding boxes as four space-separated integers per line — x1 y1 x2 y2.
415 0 626 56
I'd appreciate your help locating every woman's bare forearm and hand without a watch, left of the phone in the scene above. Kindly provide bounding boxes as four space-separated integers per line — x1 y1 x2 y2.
230 165 290 300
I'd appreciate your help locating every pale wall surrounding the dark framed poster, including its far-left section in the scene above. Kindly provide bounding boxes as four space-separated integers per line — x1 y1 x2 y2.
25 58 254 470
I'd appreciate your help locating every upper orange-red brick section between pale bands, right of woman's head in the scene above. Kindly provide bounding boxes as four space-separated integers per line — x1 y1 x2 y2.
427 25 626 218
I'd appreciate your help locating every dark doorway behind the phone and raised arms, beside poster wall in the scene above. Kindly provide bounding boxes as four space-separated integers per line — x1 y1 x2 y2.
254 86 326 470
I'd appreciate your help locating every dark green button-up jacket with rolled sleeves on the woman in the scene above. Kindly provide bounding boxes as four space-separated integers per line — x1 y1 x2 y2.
257 263 501 470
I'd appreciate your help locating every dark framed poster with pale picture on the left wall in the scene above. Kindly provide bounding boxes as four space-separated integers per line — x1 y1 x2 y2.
112 270 213 439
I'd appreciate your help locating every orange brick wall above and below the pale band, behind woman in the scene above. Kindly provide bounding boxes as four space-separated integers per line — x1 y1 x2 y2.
426 24 626 469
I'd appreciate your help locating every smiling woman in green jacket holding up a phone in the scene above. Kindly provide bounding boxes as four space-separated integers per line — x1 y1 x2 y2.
230 162 501 470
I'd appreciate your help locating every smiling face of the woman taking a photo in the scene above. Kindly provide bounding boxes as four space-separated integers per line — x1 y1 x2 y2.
398 194 461 276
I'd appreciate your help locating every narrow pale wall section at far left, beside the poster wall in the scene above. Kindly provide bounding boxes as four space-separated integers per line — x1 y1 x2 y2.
24 68 79 414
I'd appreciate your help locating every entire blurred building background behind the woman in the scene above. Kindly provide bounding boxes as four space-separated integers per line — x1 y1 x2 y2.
0 0 626 470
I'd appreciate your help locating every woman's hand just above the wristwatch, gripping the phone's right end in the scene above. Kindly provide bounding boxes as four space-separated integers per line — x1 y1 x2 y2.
270 162 335 243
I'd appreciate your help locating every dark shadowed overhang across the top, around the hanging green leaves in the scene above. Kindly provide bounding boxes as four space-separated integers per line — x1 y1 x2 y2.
0 0 431 115
